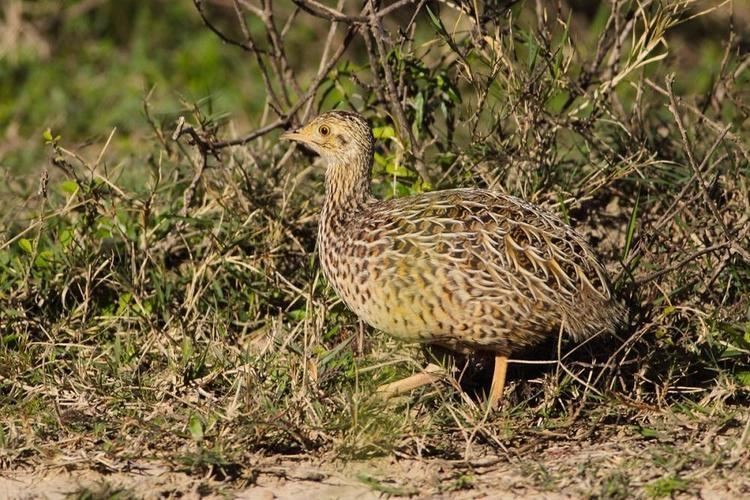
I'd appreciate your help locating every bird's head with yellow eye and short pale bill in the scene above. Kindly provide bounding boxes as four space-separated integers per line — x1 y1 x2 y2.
281 111 373 165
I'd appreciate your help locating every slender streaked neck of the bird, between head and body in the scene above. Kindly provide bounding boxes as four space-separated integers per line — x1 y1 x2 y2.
324 149 372 215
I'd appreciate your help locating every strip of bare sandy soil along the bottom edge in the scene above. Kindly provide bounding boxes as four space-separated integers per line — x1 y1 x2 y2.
0 409 750 500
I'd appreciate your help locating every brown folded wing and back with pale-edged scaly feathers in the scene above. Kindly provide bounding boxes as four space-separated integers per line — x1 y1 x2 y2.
360 189 610 303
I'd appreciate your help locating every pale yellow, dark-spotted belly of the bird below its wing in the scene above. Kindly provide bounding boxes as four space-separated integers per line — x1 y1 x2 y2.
331 248 560 353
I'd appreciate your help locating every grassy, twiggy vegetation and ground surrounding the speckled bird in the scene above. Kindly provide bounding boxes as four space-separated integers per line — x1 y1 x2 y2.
0 0 750 498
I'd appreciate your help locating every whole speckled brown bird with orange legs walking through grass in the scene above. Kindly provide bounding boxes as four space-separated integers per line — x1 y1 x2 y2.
281 110 626 407
